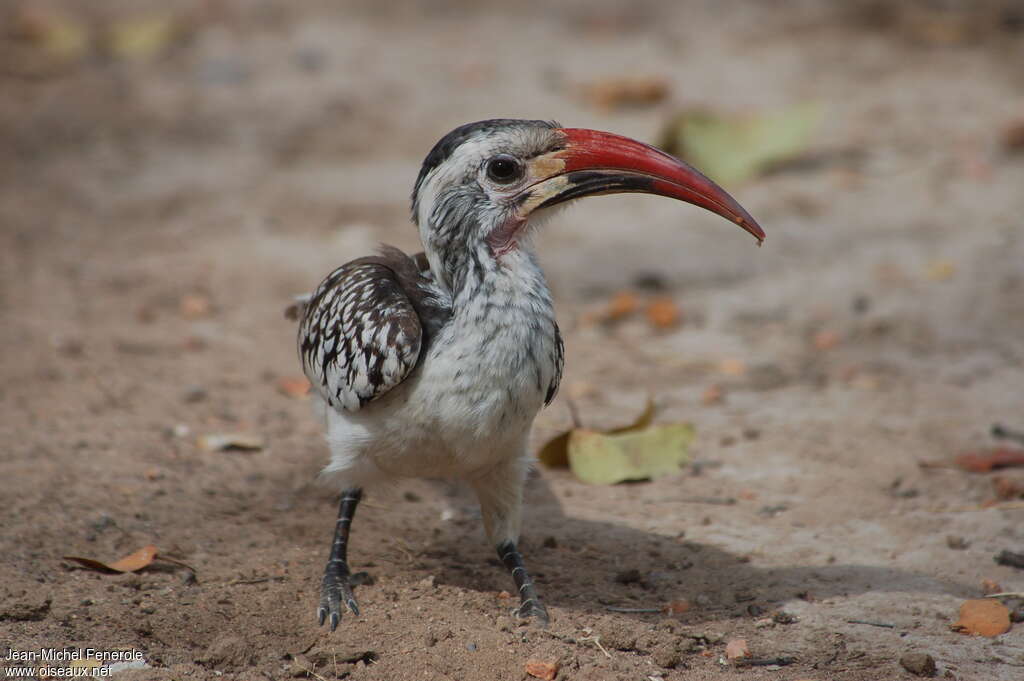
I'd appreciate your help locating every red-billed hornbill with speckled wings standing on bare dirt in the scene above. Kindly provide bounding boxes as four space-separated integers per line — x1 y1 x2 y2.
292 119 765 632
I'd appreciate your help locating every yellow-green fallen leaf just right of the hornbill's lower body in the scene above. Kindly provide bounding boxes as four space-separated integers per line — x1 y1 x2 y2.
567 423 693 484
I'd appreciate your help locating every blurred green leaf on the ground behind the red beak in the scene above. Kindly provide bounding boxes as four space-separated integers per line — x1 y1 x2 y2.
658 103 822 184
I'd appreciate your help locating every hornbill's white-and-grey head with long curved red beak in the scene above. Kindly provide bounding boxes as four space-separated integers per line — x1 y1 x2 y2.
413 119 765 288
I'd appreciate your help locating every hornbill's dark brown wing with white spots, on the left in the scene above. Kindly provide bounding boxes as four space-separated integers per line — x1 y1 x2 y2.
299 256 423 411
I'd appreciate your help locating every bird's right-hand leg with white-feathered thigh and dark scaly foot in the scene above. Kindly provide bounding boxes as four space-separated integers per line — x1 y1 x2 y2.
472 459 550 626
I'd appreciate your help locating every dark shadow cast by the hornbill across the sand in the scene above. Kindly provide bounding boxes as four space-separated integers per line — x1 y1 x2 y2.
376 476 976 623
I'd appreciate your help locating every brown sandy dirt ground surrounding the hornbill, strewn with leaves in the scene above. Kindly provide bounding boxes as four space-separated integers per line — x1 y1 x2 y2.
0 0 1024 681
